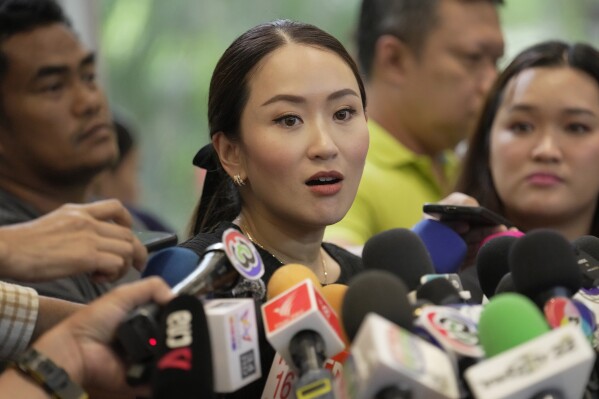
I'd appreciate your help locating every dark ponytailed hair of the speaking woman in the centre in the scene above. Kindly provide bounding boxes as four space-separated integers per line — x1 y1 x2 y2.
190 20 366 235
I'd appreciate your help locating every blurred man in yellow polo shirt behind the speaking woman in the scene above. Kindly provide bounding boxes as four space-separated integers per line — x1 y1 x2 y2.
325 0 504 247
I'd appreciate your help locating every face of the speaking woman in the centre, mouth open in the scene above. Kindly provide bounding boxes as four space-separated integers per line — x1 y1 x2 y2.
240 44 368 228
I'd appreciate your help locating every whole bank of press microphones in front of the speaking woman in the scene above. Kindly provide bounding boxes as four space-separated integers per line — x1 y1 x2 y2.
111 225 599 399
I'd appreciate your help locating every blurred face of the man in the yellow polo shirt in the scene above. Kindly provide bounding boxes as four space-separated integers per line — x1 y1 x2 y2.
404 0 504 154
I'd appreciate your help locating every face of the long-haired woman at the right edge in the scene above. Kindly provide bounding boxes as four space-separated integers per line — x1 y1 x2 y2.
490 67 599 227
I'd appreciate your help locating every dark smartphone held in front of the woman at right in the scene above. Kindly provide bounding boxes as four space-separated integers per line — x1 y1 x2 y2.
422 204 514 228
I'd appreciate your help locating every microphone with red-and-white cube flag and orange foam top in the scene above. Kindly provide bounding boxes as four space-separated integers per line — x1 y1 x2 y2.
262 266 345 398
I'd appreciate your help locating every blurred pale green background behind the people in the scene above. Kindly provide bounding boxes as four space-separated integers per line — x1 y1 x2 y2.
56 0 599 239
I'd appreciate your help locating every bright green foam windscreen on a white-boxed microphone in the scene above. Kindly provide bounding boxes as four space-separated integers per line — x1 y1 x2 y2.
478 292 549 358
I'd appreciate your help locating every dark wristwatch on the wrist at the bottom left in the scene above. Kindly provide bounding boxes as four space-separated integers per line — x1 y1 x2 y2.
11 348 88 399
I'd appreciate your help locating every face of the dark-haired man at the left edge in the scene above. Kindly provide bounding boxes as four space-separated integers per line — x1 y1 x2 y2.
0 24 118 184
